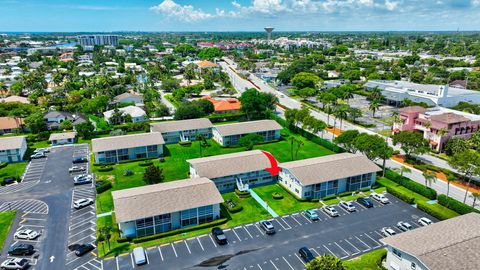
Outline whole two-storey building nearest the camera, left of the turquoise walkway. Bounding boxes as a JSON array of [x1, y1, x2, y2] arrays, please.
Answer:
[[112, 178, 224, 237]]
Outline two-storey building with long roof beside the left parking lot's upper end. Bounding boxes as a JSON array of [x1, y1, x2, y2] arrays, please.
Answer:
[[92, 132, 165, 163]]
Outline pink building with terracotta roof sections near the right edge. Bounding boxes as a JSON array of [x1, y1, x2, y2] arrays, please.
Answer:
[[393, 106, 480, 151]]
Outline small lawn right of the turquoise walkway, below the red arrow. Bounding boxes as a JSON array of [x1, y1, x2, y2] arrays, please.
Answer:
[[253, 184, 322, 215]]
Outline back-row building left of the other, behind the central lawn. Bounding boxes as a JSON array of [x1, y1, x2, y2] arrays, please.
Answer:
[[150, 118, 213, 144]]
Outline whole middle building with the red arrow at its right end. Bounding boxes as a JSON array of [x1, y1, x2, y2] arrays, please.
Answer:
[[187, 150, 277, 192]]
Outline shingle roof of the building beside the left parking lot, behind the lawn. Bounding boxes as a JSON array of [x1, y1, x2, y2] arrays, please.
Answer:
[[92, 132, 165, 153]]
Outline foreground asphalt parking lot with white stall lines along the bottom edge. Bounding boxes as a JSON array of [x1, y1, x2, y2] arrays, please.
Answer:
[[103, 195, 436, 270]]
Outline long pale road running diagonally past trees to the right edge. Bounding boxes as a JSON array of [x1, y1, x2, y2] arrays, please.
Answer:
[[221, 58, 480, 209]]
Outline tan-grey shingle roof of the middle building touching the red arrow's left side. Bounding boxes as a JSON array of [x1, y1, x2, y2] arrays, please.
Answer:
[[187, 150, 270, 179]]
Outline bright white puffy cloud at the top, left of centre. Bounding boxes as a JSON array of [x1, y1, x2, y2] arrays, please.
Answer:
[[150, 0, 214, 23]]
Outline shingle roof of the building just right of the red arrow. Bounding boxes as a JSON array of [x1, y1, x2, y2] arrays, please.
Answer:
[[279, 153, 380, 185]]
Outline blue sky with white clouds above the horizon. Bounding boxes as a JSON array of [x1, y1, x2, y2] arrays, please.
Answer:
[[0, 0, 480, 32]]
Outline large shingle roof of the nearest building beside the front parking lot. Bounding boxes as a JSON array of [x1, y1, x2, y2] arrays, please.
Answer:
[[112, 178, 224, 222]]
